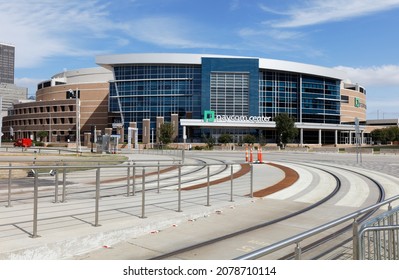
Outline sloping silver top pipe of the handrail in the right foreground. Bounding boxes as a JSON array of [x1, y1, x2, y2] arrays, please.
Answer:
[[235, 195, 399, 260]]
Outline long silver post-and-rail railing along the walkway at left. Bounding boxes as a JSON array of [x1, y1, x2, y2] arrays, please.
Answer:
[[0, 160, 253, 238]]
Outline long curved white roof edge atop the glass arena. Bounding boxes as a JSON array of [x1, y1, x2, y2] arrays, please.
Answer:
[[96, 53, 347, 80]]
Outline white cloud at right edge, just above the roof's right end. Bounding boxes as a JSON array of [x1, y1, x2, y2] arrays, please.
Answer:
[[335, 65, 399, 87]]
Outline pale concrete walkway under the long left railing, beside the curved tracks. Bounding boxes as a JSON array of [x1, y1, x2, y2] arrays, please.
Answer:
[[0, 155, 290, 259]]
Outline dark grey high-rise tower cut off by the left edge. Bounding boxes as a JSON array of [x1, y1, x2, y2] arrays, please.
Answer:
[[0, 44, 15, 84]]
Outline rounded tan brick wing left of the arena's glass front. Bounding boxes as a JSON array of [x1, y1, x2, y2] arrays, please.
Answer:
[[3, 67, 112, 142]]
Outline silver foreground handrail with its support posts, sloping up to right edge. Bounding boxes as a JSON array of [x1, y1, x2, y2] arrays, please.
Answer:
[[236, 195, 399, 260]]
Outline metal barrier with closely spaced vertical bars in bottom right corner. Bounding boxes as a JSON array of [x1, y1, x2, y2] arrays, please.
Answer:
[[355, 203, 399, 260]]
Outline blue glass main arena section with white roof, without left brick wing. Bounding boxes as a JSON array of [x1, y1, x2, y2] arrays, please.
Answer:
[[96, 53, 366, 145]]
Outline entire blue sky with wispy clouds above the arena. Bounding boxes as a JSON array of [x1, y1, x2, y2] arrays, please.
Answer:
[[0, 0, 399, 119]]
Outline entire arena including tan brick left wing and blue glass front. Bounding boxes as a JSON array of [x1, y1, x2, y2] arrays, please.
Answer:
[[3, 53, 368, 148]]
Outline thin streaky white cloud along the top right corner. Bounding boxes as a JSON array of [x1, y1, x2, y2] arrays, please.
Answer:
[[261, 0, 399, 28]]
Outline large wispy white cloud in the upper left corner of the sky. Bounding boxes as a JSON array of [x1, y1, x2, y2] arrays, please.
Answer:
[[0, 0, 115, 68]]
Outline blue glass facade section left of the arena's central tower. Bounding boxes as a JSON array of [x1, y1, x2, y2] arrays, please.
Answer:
[[109, 65, 201, 139]]
